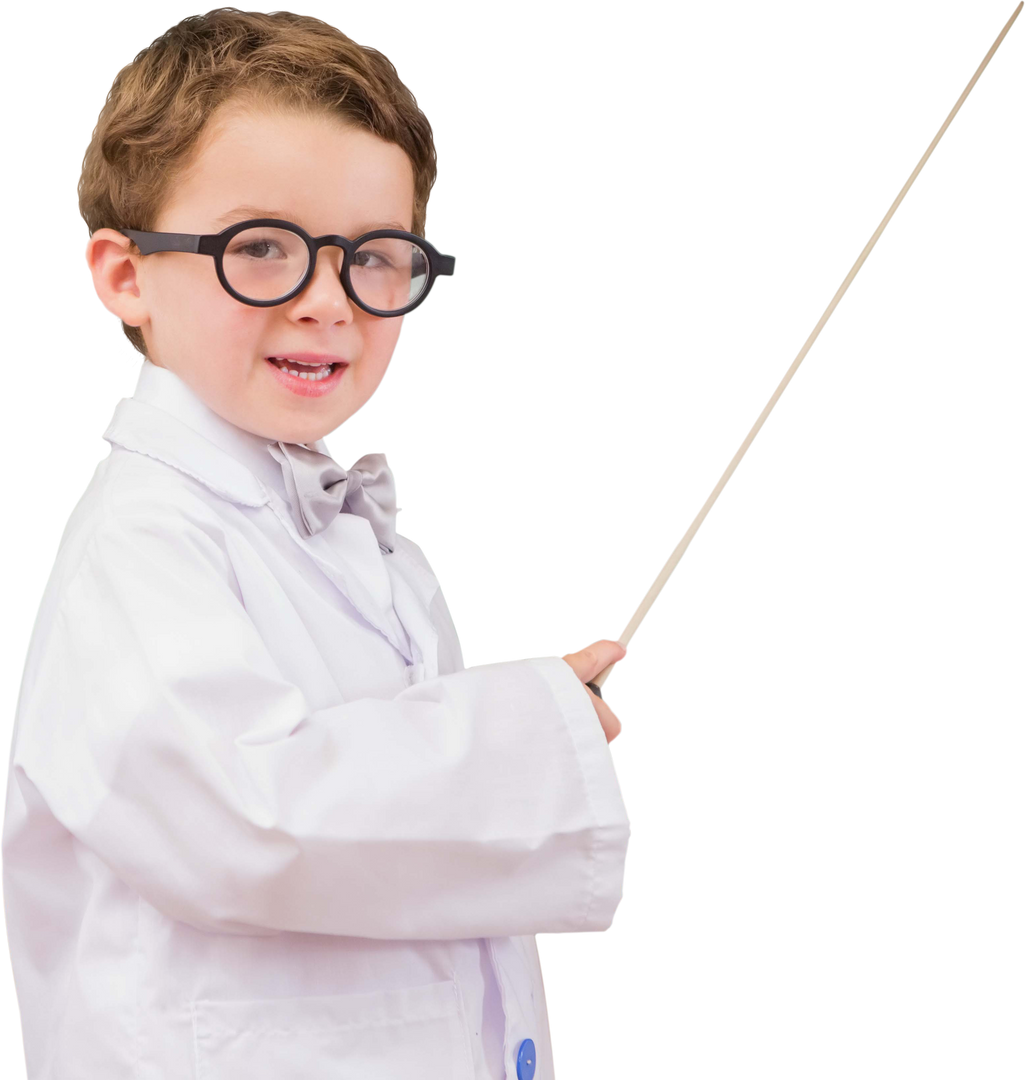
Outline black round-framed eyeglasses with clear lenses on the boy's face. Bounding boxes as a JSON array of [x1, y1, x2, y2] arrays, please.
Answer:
[[118, 217, 459, 319]]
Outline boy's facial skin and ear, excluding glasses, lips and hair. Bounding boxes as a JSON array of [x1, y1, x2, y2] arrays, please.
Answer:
[[82, 107, 414, 443]]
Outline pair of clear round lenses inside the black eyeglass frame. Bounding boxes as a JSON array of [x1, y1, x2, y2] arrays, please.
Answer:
[[224, 226, 429, 312]]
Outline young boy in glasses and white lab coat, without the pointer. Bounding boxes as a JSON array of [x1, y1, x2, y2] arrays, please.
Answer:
[[2, 9, 632, 1080]]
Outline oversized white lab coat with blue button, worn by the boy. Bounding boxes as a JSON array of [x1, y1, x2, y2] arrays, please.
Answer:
[[0, 363, 632, 1080]]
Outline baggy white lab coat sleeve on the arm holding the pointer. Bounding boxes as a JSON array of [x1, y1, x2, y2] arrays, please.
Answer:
[[13, 494, 631, 940]]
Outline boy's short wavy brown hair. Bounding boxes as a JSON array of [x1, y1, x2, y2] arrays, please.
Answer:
[[75, 4, 441, 367]]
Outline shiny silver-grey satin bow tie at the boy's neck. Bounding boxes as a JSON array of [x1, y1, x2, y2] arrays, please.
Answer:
[[267, 442, 405, 552]]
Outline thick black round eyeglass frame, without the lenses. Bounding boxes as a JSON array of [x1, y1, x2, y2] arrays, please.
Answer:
[[118, 217, 459, 319]]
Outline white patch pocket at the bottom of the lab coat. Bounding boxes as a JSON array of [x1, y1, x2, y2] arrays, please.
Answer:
[[192, 981, 473, 1080]]
